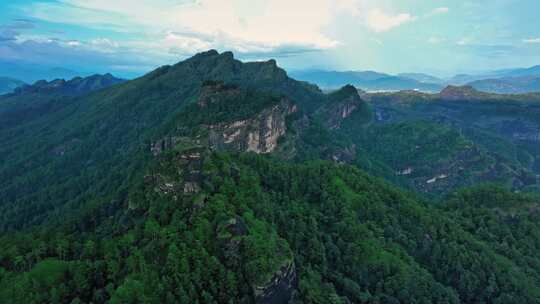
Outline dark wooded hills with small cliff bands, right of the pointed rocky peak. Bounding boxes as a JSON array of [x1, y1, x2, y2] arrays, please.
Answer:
[[358, 86, 540, 193]]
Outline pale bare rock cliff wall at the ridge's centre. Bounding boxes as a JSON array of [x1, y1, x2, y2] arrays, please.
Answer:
[[208, 98, 297, 153]]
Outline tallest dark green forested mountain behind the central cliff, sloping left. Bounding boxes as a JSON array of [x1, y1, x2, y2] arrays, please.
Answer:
[[0, 51, 325, 227]]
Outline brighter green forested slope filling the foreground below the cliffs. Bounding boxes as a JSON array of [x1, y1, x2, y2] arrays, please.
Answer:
[[0, 152, 540, 303]]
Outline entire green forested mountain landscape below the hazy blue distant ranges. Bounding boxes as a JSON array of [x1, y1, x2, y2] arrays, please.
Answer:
[[0, 51, 540, 303]]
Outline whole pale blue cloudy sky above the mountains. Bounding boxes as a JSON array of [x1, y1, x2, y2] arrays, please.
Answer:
[[0, 0, 540, 77]]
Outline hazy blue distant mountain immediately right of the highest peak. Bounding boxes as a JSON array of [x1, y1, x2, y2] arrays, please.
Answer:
[[292, 70, 442, 92]]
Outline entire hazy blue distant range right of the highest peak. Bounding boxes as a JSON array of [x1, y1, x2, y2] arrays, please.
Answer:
[[291, 66, 540, 94]]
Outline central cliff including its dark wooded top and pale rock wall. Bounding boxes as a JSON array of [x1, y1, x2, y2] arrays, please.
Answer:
[[150, 83, 297, 156]]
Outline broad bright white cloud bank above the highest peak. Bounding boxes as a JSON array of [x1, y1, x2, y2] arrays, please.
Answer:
[[24, 0, 365, 52]]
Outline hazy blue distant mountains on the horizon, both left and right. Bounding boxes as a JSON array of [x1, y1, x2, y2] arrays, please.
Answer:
[[4, 61, 540, 94]]
